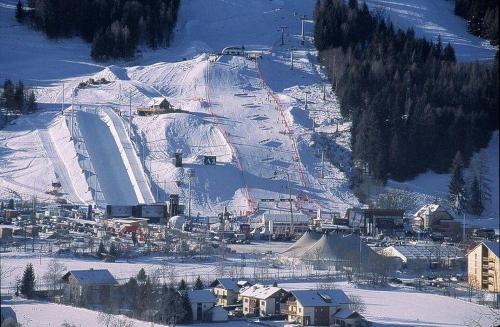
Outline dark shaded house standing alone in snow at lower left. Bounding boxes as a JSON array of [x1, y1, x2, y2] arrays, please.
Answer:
[[62, 268, 118, 305]]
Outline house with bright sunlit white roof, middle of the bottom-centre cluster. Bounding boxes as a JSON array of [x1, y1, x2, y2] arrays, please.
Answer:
[[241, 285, 288, 317]]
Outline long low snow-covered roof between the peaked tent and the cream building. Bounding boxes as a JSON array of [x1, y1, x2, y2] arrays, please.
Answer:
[[384, 244, 464, 259]]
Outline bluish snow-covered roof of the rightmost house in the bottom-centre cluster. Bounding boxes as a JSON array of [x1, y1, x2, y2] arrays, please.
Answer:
[[292, 290, 351, 307]]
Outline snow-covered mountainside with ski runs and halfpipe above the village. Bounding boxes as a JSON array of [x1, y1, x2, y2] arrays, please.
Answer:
[[0, 0, 498, 215]]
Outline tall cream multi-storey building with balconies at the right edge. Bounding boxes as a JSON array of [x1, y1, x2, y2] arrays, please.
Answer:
[[467, 241, 500, 293]]
